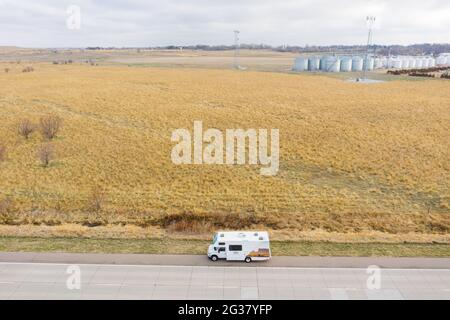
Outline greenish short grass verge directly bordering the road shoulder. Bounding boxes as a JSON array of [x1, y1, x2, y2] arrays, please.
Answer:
[[0, 237, 450, 257]]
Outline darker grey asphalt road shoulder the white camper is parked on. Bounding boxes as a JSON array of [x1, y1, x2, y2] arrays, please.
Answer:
[[0, 252, 450, 269]]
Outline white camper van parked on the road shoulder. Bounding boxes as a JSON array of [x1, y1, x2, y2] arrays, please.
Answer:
[[208, 231, 271, 263]]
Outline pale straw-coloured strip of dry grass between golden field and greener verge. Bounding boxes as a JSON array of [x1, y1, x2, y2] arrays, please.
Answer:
[[0, 224, 450, 244]]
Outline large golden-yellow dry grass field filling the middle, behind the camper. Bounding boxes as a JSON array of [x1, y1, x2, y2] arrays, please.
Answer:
[[0, 63, 450, 238]]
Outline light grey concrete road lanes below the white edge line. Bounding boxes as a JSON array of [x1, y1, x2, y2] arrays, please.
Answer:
[[0, 262, 450, 300]]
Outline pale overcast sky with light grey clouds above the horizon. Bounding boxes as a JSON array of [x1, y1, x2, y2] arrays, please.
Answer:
[[0, 0, 450, 47]]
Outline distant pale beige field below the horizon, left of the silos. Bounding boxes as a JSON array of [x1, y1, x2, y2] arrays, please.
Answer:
[[0, 47, 297, 72]]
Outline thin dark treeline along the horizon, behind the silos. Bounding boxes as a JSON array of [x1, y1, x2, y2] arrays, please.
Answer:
[[86, 43, 450, 56]]
